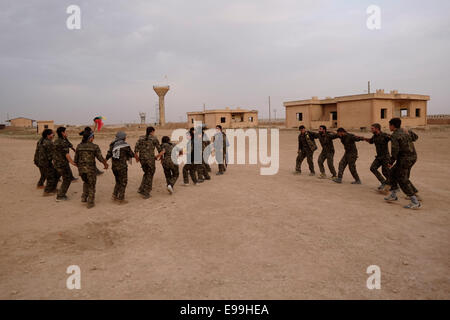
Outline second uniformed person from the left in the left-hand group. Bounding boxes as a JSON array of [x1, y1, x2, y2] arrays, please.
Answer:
[[53, 127, 75, 201]]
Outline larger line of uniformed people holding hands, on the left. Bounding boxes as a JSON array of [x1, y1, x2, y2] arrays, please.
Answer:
[[34, 125, 229, 208]]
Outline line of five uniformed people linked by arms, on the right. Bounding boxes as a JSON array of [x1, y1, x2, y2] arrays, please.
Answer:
[[295, 118, 421, 209]]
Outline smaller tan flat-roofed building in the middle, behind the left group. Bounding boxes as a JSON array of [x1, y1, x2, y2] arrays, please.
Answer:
[[187, 108, 258, 128]]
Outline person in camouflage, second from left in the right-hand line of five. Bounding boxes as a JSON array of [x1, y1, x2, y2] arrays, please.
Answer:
[[310, 125, 338, 179]]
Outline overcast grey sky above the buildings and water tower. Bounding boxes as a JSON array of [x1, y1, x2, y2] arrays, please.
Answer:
[[0, 0, 450, 124]]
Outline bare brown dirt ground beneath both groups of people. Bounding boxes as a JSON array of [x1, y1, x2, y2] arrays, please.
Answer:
[[0, 130, 450, 299]]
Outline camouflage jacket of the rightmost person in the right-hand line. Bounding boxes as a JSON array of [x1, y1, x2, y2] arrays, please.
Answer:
[[390, 129, 419, 164]]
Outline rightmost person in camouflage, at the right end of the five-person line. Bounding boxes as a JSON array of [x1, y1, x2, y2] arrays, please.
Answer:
[[385, 118, 422, 209]]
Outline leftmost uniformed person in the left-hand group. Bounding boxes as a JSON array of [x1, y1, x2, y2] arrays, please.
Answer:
[[38, 129, 59, 196]]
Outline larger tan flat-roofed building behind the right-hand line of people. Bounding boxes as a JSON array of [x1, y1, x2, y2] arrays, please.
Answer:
[[284, 90, 430, 129]]
